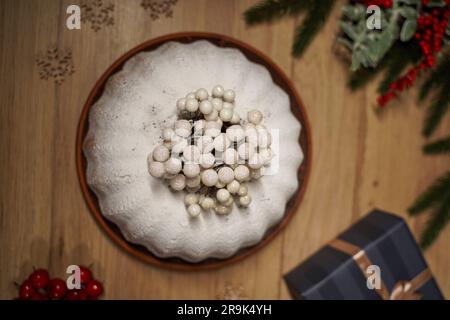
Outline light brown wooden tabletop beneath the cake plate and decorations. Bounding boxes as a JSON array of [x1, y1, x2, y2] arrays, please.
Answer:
[[0, 0, 450, 299]]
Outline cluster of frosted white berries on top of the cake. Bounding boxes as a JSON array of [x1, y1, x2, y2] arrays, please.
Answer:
[[148, 85, 273, 217]]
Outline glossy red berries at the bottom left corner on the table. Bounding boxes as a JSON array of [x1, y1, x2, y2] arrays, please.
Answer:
[[18, 266, 103, 300]]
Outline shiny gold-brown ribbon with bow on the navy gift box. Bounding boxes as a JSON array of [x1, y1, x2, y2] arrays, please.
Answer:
[[329, 239, 432, 300]]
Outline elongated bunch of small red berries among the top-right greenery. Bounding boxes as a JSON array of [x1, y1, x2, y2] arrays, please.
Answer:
[[377, 0, 450, 108]]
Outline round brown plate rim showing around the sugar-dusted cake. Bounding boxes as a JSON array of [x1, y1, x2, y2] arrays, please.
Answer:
[[76, 32, 312, 271]]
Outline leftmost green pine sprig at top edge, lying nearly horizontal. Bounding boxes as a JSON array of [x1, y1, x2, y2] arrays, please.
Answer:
[[244, 0, 312, 25]]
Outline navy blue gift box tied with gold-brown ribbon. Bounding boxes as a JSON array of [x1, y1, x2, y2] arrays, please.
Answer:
[[284, 210, 444, 300]]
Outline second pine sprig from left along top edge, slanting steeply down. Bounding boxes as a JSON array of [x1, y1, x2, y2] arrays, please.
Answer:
[[292, 0, 336, 57]]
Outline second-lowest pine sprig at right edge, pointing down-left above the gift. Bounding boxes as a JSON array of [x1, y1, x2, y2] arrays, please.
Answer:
[[408, 171, 450, 216]]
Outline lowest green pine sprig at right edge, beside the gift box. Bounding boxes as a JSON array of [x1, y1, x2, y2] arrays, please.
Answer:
[[420, 195, 450, 250]]
